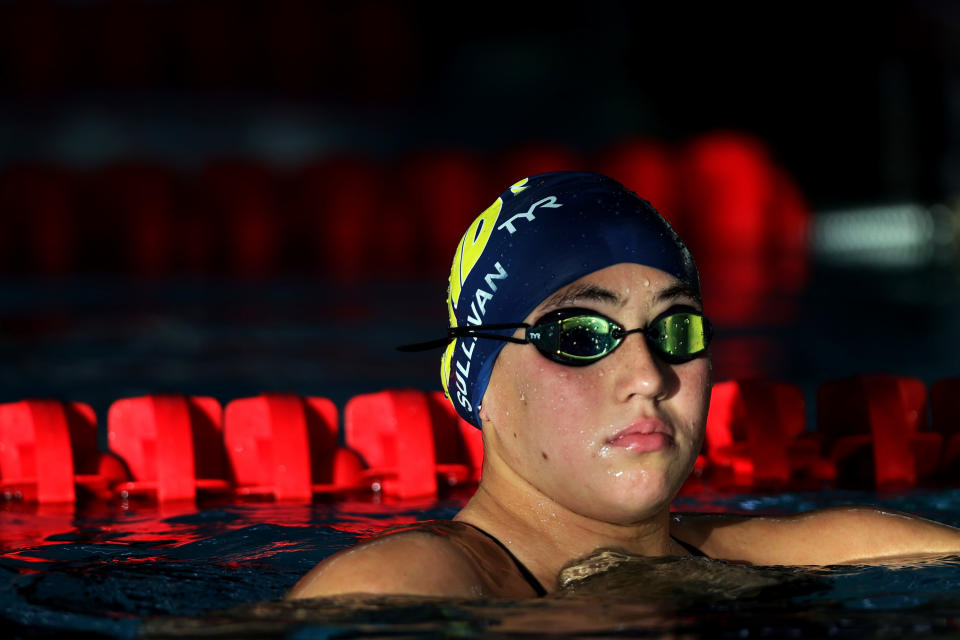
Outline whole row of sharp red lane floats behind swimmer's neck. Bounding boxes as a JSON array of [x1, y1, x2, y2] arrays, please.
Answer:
[[0, 374, 960, 508]]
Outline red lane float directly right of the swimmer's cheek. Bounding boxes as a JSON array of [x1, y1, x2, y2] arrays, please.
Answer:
[[706, 380, 835, 488]]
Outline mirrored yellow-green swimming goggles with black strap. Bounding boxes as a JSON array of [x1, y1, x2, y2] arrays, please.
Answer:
[[397, 307, 713, 367]]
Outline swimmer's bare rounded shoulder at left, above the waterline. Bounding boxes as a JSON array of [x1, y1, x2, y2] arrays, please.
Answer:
[[287, 527, 483, 598]]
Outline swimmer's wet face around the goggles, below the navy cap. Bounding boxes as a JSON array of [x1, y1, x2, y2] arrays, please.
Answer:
[[480, 263, 710, 524]]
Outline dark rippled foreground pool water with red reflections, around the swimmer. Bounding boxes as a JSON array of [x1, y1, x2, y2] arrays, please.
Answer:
[[0, 489, 960, 638]]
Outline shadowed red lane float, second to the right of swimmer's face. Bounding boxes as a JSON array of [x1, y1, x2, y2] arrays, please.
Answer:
[[817, 374, 943, 489]]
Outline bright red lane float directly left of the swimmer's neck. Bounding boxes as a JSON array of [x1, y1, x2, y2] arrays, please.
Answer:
[[344, 390, 482, 498]]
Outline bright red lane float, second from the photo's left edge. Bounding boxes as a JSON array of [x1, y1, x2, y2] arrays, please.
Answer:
[[107, 394, 231, 502]]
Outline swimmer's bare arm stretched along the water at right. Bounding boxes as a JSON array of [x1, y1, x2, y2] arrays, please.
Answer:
[[671, 506, 960, 565]]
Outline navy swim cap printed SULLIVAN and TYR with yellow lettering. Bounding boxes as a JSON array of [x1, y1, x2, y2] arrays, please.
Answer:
[[440, 171, 700, 427]]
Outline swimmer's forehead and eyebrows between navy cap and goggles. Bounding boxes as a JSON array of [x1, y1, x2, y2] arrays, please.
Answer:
[[536, 263, 700, 311]]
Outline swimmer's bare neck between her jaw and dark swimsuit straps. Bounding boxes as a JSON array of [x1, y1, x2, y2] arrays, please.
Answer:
[[455, 442, 683, 591]]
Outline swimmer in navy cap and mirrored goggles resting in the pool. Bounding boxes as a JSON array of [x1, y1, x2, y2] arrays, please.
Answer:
[[288, 172, 960, 598]]
